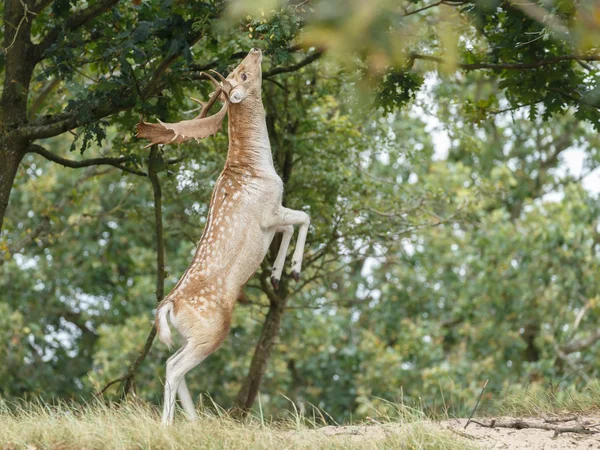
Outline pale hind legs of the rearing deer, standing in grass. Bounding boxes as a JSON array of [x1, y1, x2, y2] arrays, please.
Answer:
[[162, 343, 209, 425]]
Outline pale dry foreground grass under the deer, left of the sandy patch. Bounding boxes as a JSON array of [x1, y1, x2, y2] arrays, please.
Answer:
[[0, 402, 476, 450]]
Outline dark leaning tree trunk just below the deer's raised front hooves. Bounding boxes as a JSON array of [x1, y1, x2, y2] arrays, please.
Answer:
[[235, 279, 288, 415]]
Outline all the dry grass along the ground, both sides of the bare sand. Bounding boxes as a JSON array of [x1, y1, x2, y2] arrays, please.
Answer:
[[0, 383, 600, 450]]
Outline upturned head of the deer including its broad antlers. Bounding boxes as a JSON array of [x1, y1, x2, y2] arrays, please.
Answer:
[[136, 48, 262, 148]]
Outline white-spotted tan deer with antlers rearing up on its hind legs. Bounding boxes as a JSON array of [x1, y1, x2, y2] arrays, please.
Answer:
[[138, 48, 310, 424]]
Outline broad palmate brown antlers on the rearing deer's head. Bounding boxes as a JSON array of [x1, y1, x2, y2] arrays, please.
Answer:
[[136, 72, 231, 148]]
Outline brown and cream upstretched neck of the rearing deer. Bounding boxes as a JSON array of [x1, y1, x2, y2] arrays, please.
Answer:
[[227, 97, 275, 171]]
